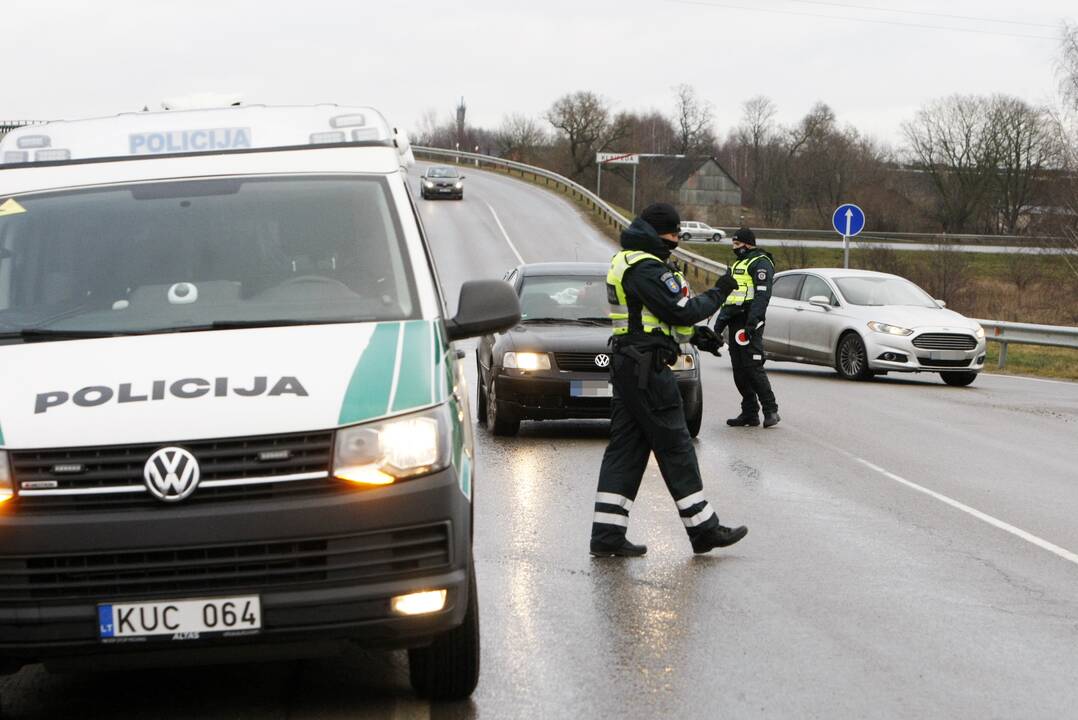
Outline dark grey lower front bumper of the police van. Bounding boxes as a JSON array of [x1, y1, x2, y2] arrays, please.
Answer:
[[0, 468, 471, 669]]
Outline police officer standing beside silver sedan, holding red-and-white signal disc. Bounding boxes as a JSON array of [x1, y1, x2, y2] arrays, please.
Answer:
[[715, 227, 780, 428]]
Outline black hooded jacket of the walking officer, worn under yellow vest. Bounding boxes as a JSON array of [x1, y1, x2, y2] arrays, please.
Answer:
[[621, 218, 725, 351]]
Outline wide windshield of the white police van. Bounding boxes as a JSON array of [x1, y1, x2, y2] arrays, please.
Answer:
[[0, 177, 417, 334]]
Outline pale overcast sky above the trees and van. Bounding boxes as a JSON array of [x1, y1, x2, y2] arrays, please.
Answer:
[[0, 0, 1078, 142]]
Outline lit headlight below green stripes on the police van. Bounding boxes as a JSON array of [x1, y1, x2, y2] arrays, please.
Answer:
[[333, 404, 452, 485]]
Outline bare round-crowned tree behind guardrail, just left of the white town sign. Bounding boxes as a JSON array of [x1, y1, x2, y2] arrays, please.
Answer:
[[547, 91, 627, 178]]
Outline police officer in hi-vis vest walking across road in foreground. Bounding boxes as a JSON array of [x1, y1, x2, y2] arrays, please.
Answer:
[[591, 203, 748, 557]]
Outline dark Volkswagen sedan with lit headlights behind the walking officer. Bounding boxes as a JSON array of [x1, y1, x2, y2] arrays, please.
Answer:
[[476, 263, 704, 437]]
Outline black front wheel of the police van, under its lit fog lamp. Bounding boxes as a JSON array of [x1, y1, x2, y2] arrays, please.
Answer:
[[407, 567, 479, 701]]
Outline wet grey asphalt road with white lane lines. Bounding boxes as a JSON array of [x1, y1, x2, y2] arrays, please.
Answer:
[[0, 164, 1078, 718]]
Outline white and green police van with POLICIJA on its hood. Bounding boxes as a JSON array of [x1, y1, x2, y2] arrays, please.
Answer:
[[0, 106, 520, 698]]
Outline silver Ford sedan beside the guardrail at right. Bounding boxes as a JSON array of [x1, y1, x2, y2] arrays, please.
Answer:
[[763, 268, 985, 386]]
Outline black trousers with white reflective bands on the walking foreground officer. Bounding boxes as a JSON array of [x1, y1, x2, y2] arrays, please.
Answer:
[[592, 350, 719, 543]]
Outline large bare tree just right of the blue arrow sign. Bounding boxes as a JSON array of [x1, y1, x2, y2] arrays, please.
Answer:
[[902, 95, 996, 233]]
